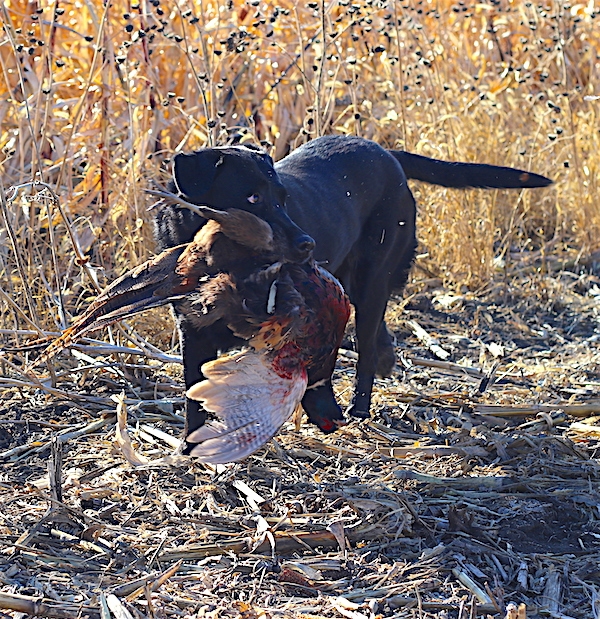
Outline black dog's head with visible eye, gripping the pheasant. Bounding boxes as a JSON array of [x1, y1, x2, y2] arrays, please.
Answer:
[[173, 146, 315, 262]]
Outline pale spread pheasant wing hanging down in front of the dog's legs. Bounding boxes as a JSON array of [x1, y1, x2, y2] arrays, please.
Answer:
[[187, 350, 307, 464]]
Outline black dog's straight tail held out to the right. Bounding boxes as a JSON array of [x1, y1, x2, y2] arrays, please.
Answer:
[[390, 150, 552, 189]]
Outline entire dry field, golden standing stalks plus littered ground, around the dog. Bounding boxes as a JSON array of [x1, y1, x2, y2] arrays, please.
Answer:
[[0, 0, 600, 619]]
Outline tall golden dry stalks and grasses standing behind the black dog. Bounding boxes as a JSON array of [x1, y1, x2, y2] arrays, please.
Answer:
[[0, 0, 600, 340]]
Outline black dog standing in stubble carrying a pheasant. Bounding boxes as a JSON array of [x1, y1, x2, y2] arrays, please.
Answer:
[[155, 136, 551, 448]]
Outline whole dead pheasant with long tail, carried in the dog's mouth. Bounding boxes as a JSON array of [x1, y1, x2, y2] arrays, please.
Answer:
[[41, 201, 350, 464]]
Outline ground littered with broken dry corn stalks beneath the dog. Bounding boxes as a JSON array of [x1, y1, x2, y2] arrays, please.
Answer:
[[0, 255, 600, 619]]
